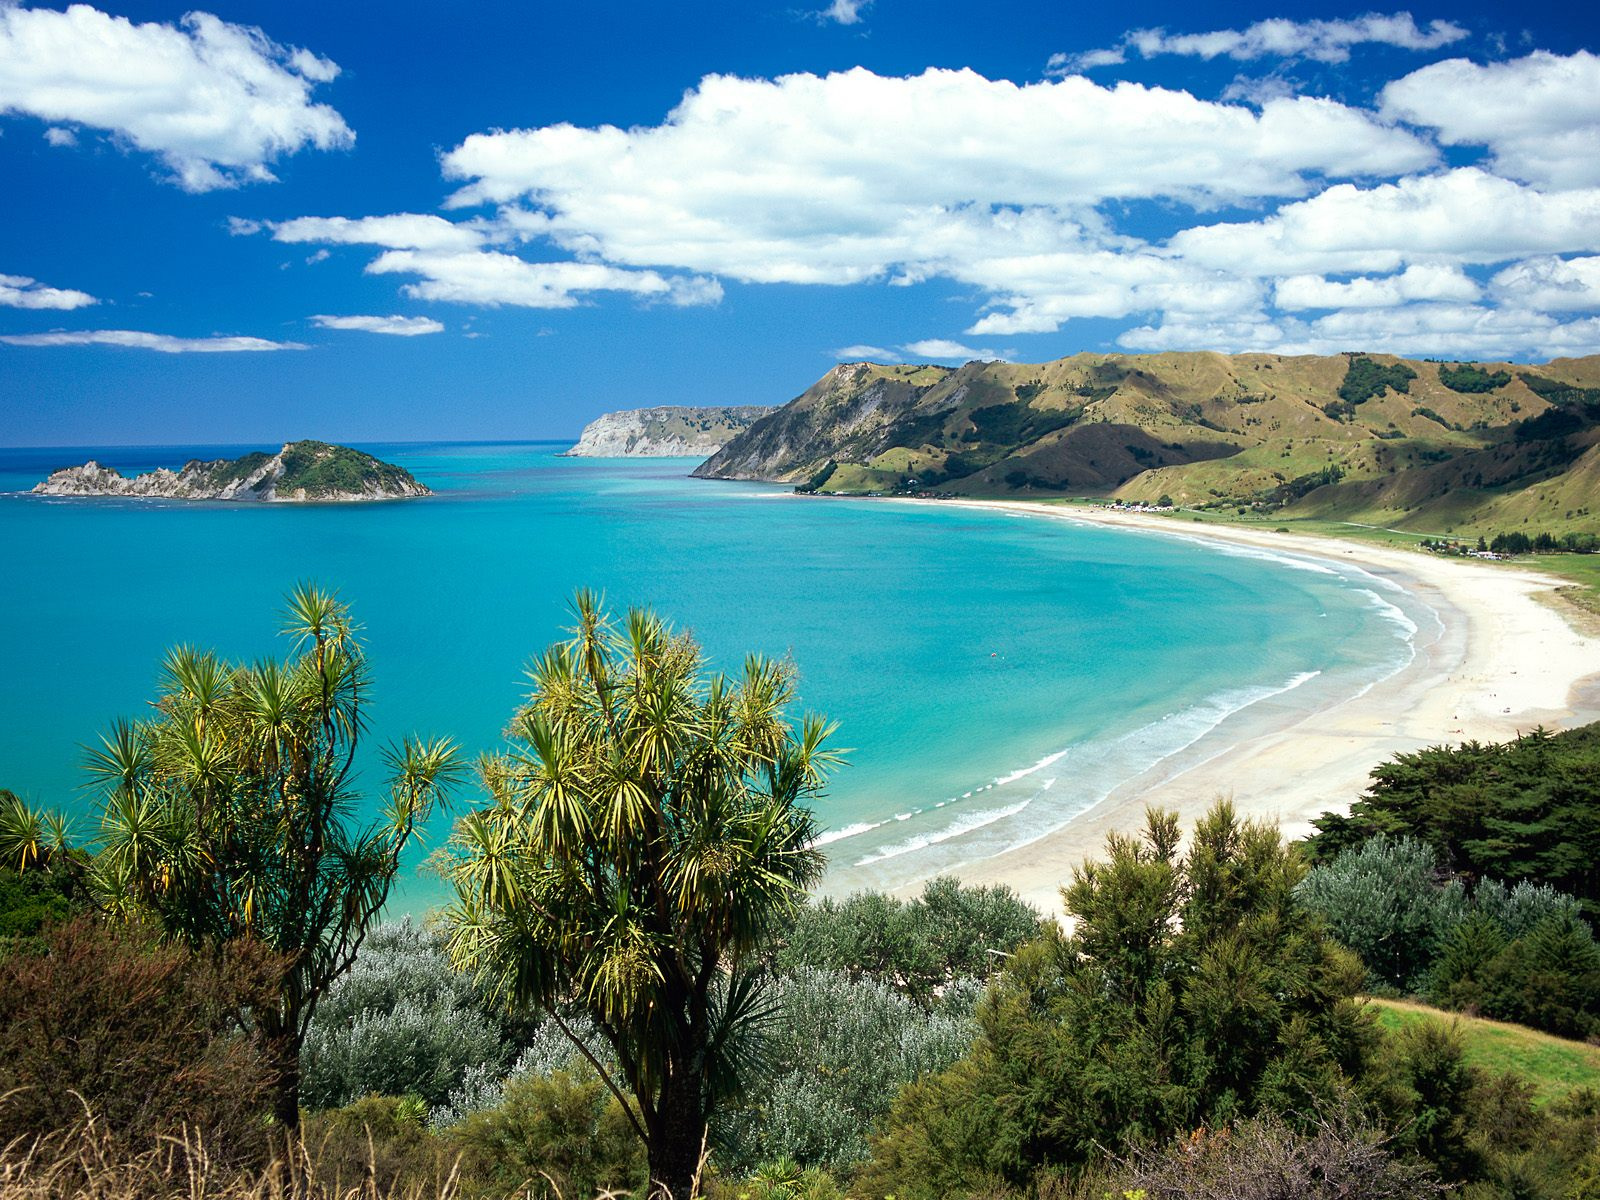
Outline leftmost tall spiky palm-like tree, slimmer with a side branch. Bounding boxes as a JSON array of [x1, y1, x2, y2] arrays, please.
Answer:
[[86, 584, 461, 1128]]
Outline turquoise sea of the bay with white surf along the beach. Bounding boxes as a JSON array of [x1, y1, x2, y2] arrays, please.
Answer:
[[0, 443, 1432, 910]]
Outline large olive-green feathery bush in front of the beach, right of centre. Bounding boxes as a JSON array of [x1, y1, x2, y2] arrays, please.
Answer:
[[864, 803, 1373, 1200]]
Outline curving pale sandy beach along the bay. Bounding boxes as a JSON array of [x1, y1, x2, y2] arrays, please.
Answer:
[[930, 501, 1600, 912]]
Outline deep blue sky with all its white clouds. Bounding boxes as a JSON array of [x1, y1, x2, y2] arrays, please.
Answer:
[[0, 0, 1600, 446]]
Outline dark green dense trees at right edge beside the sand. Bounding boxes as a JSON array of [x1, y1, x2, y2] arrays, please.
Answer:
[[1307, 725, 1600, 917]]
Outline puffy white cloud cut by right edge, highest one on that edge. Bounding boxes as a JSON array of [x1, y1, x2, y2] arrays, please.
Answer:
[[1381, 50, 1600, 187]]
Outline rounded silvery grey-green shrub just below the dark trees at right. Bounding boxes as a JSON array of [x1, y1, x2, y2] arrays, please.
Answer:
[[1294, 837, 1467, 992]]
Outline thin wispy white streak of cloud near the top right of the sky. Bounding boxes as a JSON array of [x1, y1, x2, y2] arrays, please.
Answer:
[[1050, 13, 1467, 74]]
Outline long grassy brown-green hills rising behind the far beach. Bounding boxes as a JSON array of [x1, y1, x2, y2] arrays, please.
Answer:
[[694, 352, 1600, 533]]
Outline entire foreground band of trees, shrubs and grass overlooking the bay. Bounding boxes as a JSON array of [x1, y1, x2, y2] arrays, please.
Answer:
[[0, 586, 1600, 1200]]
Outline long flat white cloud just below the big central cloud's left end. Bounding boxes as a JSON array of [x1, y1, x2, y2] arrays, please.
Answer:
[[366, 250, 722, 309]]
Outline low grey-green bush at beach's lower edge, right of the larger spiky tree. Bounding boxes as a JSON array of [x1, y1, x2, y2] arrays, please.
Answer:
[[774, 877, 1040, 1003]]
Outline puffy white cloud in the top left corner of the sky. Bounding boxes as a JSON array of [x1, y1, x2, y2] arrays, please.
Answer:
[[0, 5, 355, 192]]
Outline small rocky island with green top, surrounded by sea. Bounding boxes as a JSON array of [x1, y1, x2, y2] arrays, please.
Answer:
[[34, 442, 432, 502]]
